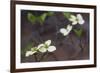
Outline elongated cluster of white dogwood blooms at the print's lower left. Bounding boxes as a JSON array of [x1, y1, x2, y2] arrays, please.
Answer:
[[25, 40, 56, 57]]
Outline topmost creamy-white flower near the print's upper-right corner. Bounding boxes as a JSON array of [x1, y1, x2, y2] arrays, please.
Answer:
[[69, 14, 85, 25]]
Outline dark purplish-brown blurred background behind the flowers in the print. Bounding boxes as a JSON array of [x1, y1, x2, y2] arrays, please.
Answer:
[[21, 10, 89, 62]]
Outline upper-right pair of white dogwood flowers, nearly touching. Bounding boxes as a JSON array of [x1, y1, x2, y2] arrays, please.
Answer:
[[60, 14, 85, 36]]
